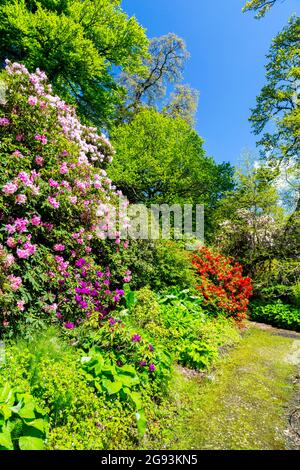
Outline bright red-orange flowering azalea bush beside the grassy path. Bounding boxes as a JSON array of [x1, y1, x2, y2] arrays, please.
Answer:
[[193, 247, 252, 320]]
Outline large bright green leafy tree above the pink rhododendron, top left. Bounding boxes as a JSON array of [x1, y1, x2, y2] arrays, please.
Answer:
[[0, 0, 148, 126]]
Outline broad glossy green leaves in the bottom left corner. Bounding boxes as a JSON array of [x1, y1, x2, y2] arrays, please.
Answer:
[[0, 382, 48, 450]]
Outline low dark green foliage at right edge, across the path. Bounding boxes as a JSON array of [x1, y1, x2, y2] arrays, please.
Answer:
[[251, 301, 300, 331]]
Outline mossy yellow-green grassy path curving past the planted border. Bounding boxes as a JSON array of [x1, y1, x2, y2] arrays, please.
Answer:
[[162, 327, 300, 450]]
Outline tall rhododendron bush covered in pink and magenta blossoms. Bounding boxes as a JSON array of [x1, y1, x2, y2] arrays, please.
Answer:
[[0, 61, 130, 331]]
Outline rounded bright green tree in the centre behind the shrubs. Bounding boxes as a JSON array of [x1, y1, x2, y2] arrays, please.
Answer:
[[108, 108, 233, 237]]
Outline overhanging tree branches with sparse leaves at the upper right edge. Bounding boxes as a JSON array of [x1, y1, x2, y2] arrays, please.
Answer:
[[250, 17, 300, 160]]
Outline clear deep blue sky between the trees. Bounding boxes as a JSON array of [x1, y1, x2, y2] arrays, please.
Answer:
[[122, 0, 299, 164]]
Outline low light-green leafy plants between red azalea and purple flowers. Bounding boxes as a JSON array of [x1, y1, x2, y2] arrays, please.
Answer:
[[121, 288, 239, 369]]
